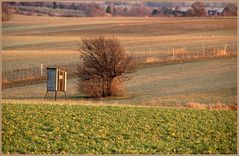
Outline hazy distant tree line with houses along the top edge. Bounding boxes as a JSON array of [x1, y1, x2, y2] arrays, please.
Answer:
[[3, 1, 237, 17]]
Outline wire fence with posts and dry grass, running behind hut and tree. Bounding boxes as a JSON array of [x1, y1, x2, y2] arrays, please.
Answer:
[[2, 44, 237, 88]]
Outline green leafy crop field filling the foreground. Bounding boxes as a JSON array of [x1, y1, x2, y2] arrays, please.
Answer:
[[2, 102, 237, 154]]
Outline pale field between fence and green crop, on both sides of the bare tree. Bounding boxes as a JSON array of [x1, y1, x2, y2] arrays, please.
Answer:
[[2, 58, 237, 106]]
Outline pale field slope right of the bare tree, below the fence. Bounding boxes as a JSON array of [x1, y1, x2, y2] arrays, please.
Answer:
[[125, 58, 237, 105]]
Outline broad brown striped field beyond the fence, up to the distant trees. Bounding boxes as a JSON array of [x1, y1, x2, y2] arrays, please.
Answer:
[[2, 15, 236, 70]]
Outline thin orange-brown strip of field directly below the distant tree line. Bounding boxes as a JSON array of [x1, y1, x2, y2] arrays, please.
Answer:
[[8, 15, 236, 25]]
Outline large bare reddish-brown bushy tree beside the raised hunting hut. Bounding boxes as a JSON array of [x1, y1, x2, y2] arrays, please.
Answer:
[[79, 37, 136, 97]]
